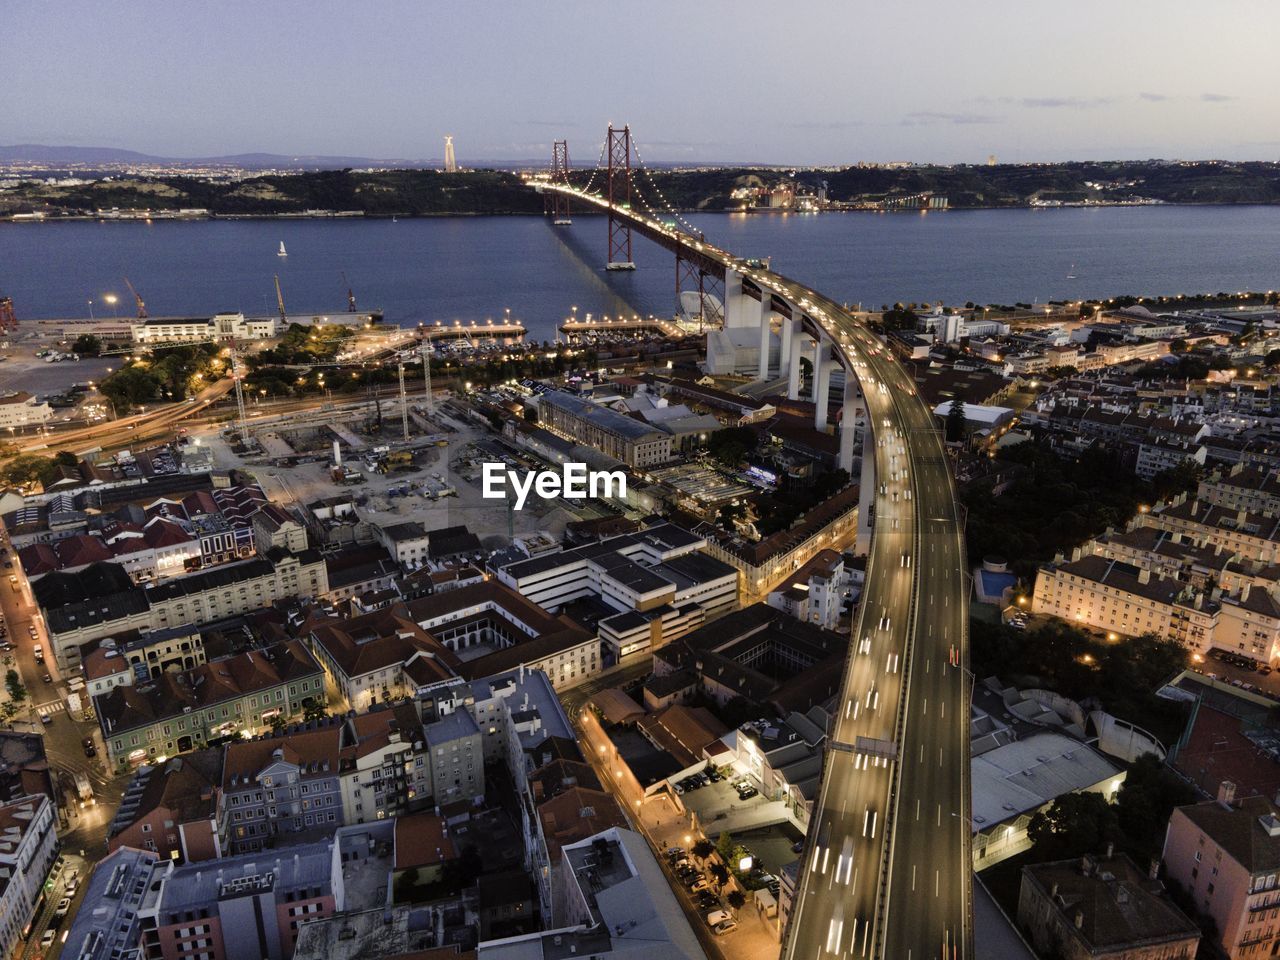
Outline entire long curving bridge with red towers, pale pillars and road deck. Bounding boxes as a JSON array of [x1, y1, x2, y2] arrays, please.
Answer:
[[529, 125, 974, 960]]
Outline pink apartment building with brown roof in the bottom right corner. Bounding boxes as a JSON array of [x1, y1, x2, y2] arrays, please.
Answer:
[[1164, 798, 1280, 960]]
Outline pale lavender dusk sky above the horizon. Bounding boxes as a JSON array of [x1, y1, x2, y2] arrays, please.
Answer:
[[0, 0, 1280, 165]]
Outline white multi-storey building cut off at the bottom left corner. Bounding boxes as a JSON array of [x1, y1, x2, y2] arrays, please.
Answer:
[[0, 794, 60, 956]]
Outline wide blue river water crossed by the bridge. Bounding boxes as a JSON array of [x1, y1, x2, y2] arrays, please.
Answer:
[[0, 206, 1280, 339]]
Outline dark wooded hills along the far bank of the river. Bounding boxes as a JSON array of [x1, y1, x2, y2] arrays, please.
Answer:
[[0, 158, 1280, 216]]
